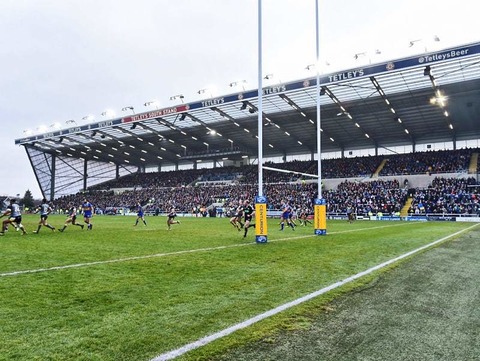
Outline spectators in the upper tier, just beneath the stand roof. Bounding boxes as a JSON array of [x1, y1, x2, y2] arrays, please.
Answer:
[[90, 149, 479, 190]]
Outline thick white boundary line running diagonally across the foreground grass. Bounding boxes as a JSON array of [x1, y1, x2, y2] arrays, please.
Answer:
[[151, 224, 478, 361]]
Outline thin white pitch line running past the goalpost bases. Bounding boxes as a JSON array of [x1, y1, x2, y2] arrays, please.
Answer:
[[0, 224, 412, 277]]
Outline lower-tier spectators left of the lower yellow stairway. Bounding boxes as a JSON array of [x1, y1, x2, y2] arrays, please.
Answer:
[[54, 180, 407, 215]]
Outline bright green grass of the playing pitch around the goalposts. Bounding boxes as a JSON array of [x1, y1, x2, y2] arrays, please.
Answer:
[[0, 215, 471, 360]]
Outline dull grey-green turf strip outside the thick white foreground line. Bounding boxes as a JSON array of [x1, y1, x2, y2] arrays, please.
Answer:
[[214, 227, 480, 361]]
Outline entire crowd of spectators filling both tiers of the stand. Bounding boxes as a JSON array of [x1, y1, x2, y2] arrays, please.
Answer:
[[54, 150, 479, 215]]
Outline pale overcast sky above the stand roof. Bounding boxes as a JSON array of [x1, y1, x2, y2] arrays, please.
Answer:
[[0, 0, 480, 198]]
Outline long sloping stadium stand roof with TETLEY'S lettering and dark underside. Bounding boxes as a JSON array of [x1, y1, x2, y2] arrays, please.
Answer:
[[15, 43, 480, 196]]
